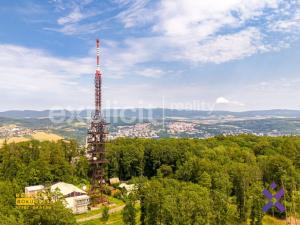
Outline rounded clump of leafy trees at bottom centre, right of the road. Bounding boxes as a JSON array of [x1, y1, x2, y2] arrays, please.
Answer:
[[141, 179, 213, 225]]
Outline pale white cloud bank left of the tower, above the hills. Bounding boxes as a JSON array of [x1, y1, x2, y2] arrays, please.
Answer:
[[0, 45, 94, 110]]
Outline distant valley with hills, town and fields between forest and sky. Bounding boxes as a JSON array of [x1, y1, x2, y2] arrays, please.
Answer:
[[0, 109, 300, 144]]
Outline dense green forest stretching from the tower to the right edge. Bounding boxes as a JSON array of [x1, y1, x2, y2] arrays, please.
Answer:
[[107, 135, 300, 225]]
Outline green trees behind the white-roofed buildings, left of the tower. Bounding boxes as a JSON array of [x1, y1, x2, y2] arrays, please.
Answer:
[[0, 141, 88, 186]]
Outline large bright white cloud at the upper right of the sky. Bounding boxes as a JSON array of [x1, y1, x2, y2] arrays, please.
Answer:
[[113, 0, 297, 63]]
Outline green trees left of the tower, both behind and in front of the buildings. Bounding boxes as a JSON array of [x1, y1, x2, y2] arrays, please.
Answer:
[[0, 141, 88, 225]]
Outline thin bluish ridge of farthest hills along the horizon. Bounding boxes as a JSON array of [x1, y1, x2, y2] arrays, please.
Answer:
[[0, 108, 300, 119]]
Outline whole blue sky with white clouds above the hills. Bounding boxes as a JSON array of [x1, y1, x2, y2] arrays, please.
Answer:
[[0, 0, 300, 111]]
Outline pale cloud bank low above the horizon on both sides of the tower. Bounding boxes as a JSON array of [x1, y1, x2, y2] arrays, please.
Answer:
[[0, 43, 300, 111]]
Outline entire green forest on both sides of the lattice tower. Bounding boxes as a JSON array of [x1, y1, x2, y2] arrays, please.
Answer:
[[0, 135, 300, 225]]
